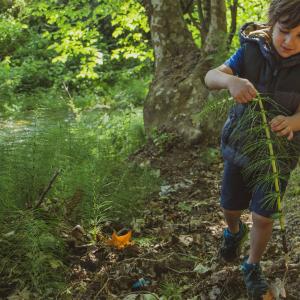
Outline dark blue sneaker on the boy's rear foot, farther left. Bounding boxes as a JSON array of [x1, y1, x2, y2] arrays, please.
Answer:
[[219, 221, 249, 262]]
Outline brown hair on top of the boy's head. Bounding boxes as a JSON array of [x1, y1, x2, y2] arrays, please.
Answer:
[[268, 0, 300, 29]]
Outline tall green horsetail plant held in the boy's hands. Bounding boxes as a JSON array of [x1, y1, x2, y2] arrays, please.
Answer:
[[198, 95, 299, 253]]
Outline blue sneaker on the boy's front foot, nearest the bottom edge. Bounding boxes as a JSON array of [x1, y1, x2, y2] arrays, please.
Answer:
[[241, 256, 269, 300]]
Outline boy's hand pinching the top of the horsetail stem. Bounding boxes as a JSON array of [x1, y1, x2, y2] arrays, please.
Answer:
[[228, 76, 257, 103]]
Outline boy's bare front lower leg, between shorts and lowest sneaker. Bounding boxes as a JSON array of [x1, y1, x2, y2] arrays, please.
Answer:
[[247, 212, 273, 264]]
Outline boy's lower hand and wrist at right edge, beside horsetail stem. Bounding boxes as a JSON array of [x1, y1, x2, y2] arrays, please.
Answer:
[[270, 105, 300, 140]]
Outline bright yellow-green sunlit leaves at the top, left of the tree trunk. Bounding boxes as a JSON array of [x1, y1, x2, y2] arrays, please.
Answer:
[[22, 0, 153, 79]]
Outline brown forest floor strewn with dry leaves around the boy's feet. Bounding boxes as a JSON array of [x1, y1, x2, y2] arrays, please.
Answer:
[[67, 142, 300, 300]]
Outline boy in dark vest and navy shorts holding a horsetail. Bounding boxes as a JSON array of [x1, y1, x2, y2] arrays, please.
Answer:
[[205, 0, 300, 299]]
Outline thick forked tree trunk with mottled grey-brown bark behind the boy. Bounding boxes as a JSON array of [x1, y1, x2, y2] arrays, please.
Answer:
[[144, 0, 226, 143]]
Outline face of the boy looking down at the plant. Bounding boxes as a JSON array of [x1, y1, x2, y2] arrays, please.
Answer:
[[272, 22, 300, 58]]
